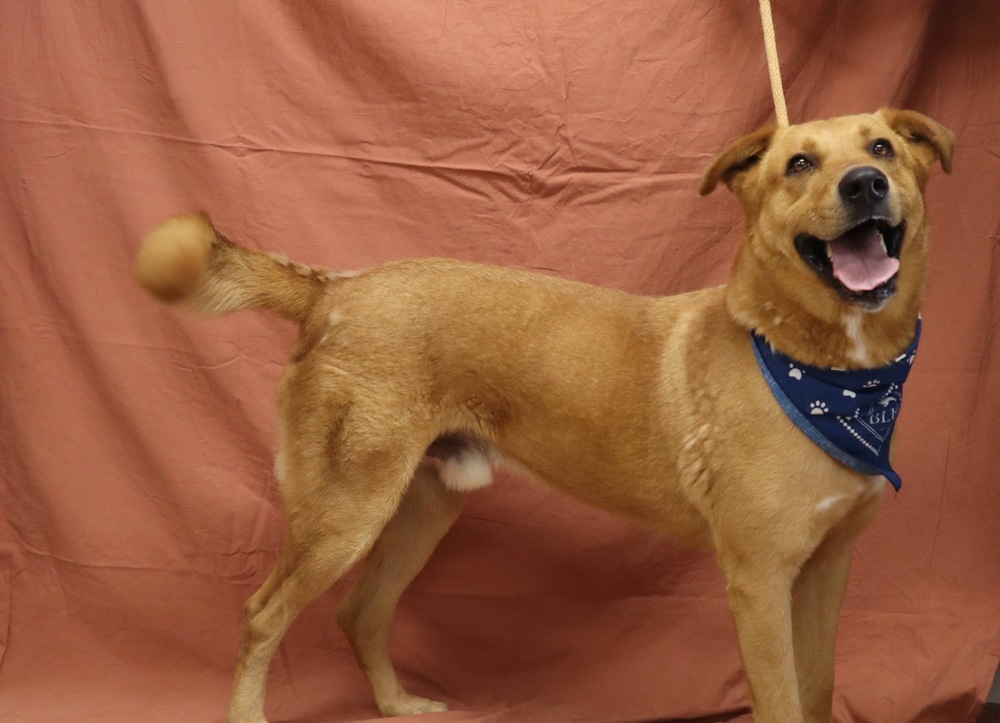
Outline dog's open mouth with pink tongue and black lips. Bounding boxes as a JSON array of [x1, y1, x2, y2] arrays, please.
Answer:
[[795, 217, 906, 307]]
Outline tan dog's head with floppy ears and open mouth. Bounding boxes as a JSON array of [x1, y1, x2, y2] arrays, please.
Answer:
[[699, 109, 954, 316]]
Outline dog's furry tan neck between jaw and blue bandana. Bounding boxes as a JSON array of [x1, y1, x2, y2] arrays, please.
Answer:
[[726, 244, 923, 369]]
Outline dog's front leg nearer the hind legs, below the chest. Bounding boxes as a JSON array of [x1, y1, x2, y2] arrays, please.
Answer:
[[719, 555, 803, 723]]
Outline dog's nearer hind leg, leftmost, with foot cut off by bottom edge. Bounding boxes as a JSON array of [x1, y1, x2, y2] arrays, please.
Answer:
[[229, 450, 412, 723]]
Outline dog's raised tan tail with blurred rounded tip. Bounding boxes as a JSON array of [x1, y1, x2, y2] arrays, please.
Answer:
[[135, 213, 339, 323]]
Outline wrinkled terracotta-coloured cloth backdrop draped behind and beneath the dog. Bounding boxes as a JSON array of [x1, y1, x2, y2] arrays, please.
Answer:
[[0, 0, 1000, 723]]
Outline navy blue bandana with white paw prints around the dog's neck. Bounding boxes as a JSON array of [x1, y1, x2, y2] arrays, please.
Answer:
[[750, 320, 920, 490]]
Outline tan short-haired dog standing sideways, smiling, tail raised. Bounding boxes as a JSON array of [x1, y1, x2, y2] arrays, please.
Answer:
[[136, 110, 953, 723]]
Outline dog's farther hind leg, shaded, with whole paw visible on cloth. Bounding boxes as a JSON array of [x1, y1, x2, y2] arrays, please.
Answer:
[[337, 464, 466, 716]]
